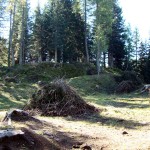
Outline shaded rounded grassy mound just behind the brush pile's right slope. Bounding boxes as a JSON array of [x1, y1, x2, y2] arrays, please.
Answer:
[[69, 74, 117, 95]]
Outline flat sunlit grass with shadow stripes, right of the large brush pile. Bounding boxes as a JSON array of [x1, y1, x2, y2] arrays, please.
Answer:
[[84, 93, 150, 128]]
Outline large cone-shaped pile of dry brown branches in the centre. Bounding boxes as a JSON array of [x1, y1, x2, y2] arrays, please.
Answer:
[[26, 79, 97, 116]]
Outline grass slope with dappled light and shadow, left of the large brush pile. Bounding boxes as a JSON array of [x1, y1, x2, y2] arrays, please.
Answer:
[[0, 83, 37, 110]]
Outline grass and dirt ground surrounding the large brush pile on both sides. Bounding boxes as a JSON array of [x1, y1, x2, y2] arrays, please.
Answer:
[[0, 75, 150, 150]]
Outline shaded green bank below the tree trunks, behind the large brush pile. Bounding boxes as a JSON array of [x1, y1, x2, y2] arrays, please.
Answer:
[[0, 63, 90, 83]]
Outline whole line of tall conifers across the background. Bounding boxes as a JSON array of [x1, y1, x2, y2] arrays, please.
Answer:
[[0, 0, 150, 82]]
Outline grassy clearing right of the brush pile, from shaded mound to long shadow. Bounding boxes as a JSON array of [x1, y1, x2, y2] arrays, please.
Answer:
[[70, 76, 150, 129]]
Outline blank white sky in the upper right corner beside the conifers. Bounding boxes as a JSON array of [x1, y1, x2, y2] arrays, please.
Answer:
[[119, 0, 150, 39]]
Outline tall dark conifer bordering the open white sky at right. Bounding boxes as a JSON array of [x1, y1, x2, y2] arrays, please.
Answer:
[[108, 2, 126, 69]]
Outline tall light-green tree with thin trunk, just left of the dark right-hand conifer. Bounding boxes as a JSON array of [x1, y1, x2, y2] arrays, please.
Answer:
[[94, 0, 114, 74]]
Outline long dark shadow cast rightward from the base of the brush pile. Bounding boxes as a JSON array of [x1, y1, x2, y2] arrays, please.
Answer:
[[65, 114, 150, 129]]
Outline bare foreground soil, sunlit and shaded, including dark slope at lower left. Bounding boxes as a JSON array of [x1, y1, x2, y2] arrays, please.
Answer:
[[0, 112, 150, 150]]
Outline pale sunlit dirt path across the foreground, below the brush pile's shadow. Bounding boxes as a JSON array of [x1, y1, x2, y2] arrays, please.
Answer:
[[1, 110, 150, 150]]
